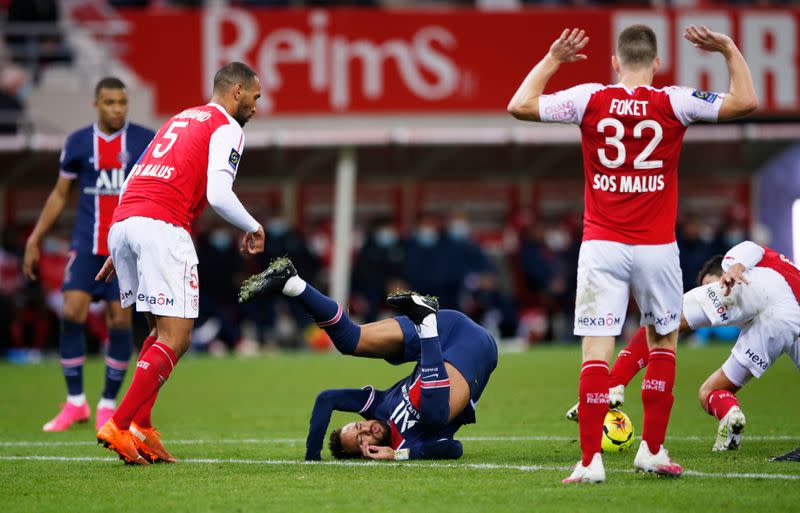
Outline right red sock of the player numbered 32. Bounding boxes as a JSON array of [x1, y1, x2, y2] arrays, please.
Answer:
[[642, 349, 675, 454]]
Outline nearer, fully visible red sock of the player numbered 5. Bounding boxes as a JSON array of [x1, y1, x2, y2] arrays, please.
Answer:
[[112, 342, 177, 429]]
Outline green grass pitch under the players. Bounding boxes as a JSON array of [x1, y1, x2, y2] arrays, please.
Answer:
[[0, 346, 800, 513]]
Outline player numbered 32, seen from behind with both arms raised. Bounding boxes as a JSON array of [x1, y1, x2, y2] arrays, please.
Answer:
[[508, 25, 758, 483]]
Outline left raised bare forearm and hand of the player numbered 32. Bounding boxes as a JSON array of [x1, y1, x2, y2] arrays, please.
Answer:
[[508, 29, 589, 121]]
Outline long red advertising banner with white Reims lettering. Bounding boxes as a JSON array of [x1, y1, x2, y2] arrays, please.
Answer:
[[119, 8, 800, 116]]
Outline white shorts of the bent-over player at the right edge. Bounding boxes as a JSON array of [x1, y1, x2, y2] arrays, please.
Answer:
[[723, 308, 800, 381]]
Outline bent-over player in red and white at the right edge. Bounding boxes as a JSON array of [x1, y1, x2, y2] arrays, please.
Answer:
[[567, 241, 800, 451]]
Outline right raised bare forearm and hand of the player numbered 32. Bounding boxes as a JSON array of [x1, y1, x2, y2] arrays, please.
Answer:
[[683, 25, 758, 121]]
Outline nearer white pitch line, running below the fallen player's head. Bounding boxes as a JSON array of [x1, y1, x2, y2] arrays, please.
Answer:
[[0, 456, 800, 481]]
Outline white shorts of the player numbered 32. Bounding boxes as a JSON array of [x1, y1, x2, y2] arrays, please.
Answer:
[[574, 240, 683, 337]]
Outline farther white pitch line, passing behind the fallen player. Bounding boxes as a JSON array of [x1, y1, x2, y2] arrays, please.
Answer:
[[0, 435, 800, 447]]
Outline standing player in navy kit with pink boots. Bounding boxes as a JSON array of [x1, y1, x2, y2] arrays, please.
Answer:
[[23, 77, 154, 431]]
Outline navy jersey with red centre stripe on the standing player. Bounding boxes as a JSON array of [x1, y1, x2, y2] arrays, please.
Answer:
[[60, 123, 155, 256]]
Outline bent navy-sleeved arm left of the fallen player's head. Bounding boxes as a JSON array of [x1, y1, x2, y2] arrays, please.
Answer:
[[306, 387, 375, 461]]
